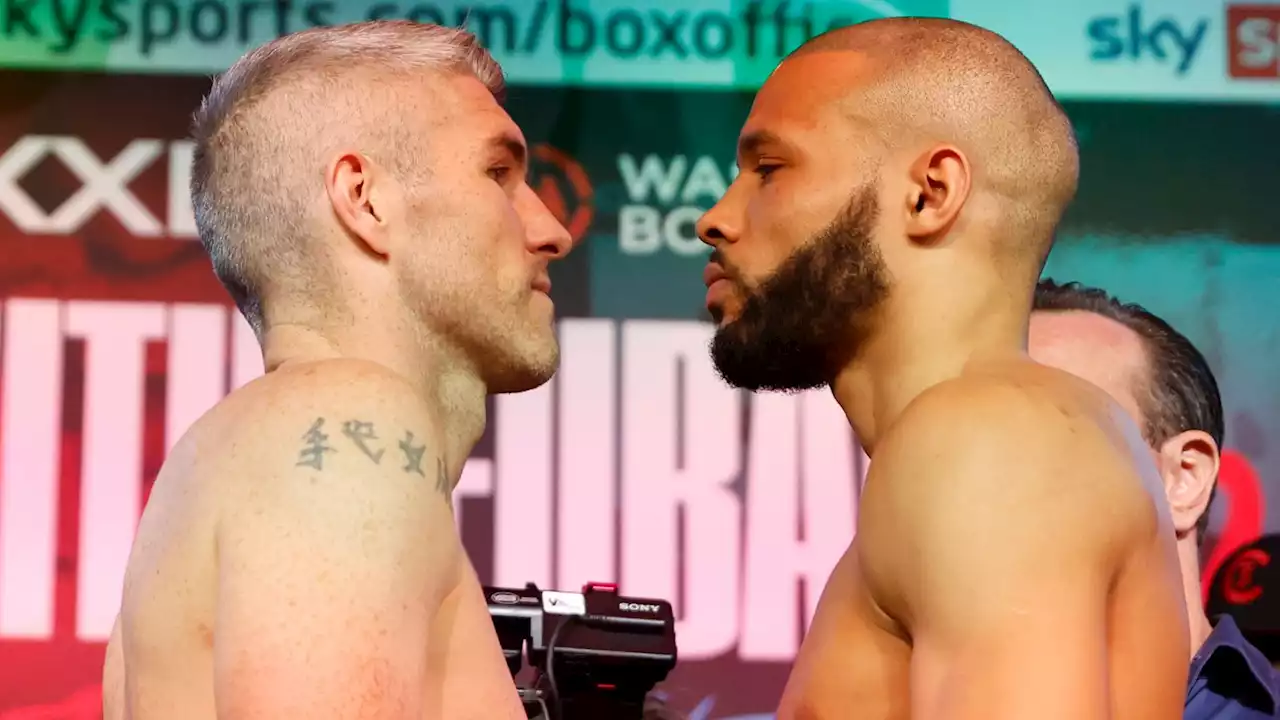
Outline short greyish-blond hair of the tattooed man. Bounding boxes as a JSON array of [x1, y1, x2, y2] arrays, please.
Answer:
[[191, 20, 506, 337]]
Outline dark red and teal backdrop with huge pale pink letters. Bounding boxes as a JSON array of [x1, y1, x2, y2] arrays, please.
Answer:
[[0, 0, 1280, 720]]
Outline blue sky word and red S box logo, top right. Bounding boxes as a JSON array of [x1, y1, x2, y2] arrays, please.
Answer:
[[1085, 3, 1280, 79]]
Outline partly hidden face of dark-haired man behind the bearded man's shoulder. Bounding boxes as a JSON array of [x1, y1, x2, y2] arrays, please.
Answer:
[[1028, 310, 1147, 428]]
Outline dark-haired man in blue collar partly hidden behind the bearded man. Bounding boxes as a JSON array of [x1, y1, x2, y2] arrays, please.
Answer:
[[1028, 281, 1280, 720]]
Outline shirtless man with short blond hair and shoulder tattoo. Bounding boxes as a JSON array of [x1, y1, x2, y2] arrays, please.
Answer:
[[104, 22, 571, 720]]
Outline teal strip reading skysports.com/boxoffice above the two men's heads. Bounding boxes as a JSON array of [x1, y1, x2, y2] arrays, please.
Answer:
[[0, 0, 947, 87]]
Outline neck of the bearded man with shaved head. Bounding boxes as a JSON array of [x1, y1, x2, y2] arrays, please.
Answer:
[[831, 271, 1030, 456]]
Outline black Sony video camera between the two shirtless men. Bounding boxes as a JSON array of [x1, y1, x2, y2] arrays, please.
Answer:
[[484, 583, 676, 720]]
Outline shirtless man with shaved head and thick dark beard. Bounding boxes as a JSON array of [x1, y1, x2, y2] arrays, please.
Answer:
[[699, 18, 1189, 720]]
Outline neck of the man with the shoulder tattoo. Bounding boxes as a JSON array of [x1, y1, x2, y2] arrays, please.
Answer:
[[260, 304, 488, 474]]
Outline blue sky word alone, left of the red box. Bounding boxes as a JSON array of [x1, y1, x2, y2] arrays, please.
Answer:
[[1085, 4, 1208, 76]]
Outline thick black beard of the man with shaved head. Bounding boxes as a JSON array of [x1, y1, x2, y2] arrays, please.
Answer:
[[712, 186, 890, 392]]
